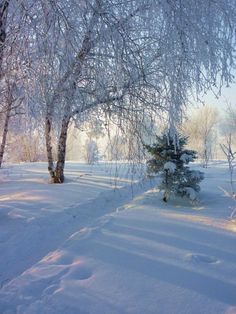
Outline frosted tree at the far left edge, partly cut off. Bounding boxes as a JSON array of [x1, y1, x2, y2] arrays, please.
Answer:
[[0, 0, 25, 168]]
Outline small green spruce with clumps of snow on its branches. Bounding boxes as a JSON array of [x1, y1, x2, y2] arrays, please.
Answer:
[[145, 132, 204, 202]]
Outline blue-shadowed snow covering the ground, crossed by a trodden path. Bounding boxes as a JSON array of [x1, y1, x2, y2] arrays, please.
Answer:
[[0, 162, 236, 314]]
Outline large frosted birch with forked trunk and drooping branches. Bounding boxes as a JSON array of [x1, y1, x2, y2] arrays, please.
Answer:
[[11, 0, 236, 183]]
